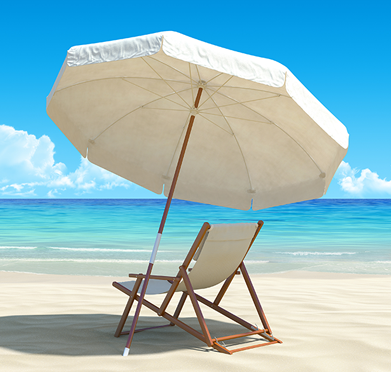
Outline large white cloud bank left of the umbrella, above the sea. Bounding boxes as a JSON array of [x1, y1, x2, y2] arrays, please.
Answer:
[[0, 125, 131, 198]]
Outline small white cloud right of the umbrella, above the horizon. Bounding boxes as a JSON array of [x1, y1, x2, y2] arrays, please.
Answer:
[[336, 161, 391, 197]]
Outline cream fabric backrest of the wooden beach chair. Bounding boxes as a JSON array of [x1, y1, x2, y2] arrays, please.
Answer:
[[177, 223, 258, 292]]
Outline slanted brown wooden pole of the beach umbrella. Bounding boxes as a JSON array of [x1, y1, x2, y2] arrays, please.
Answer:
[[123, 88, 203, 356]]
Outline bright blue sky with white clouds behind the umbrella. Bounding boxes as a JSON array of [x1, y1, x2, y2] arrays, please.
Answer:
[[0, 1, 391, 198]]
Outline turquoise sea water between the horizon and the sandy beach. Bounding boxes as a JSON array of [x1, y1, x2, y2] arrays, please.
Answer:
[[0, 199, 391, 276]]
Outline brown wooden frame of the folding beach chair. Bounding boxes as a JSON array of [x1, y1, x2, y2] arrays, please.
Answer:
[[113, 221, 282, 354]]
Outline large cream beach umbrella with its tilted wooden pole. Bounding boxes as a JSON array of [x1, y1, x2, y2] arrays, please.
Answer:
[[47, 32, 348, 354]]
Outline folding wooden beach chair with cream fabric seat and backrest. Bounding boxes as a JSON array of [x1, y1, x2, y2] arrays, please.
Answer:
[[113, 221, 281, 355]]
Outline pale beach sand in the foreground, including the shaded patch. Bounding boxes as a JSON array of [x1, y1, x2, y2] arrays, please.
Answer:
[[0, 272, 391, 372]]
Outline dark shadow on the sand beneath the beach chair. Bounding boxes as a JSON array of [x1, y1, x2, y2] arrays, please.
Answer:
[[0, 314, 261, 356]]
